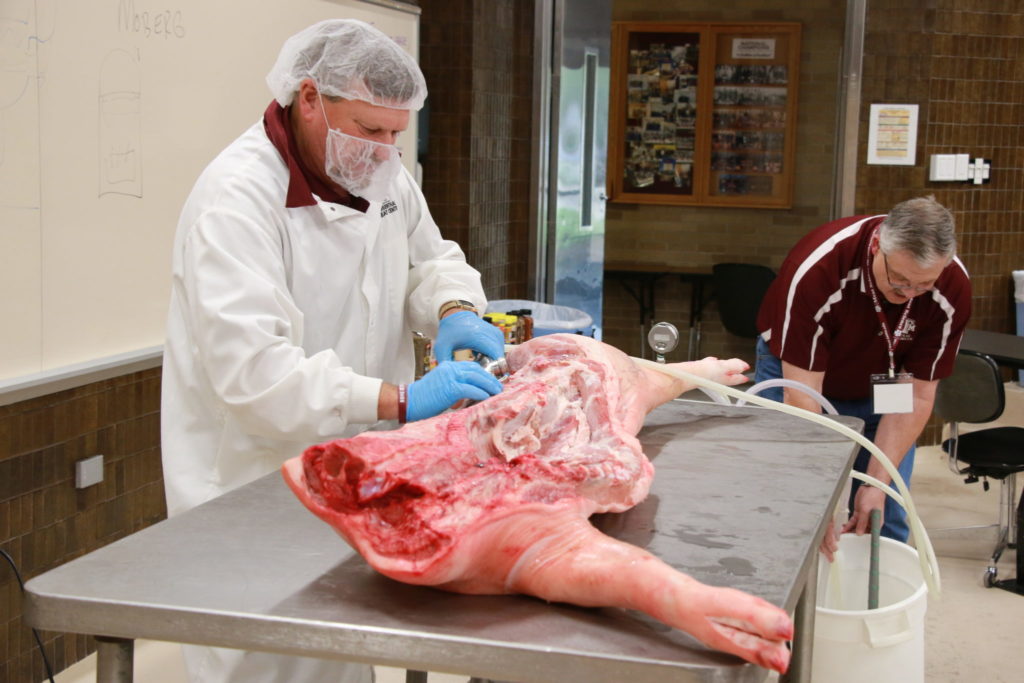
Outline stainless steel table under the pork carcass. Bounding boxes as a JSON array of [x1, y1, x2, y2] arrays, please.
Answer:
[[25, 401, 859, 683]]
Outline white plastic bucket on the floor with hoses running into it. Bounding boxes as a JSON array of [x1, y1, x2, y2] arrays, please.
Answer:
[[811, 533, 928, 683]]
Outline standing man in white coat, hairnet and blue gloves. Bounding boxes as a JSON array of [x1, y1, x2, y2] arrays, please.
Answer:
[[161, 19, 504, 683]]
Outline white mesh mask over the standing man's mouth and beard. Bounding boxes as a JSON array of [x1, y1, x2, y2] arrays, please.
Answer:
[[321, 99, 401, 202]]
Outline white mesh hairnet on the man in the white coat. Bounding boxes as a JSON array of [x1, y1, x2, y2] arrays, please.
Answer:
[[266, 19, 427, 110]]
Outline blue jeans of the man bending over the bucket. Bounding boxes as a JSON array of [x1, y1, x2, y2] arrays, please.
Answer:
[[754, 337, 916, 543]]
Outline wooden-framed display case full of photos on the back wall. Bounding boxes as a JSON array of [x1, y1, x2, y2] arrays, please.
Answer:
[[608, 22, 800, 208]]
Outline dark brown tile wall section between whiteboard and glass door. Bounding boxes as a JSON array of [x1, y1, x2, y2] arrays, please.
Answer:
[[420, 0, 534, 299]]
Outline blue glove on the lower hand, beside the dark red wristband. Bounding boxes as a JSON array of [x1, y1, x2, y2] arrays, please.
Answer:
[[406, 358, 503, 422]]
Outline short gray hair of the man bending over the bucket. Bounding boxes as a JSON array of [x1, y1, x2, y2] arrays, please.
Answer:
[[879, 195, 956, 267]]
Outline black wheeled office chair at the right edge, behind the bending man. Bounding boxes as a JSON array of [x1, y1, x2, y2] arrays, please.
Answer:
[[935, 350, 1024, 593]]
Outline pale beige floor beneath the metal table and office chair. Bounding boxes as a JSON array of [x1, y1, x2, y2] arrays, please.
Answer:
[[56, 383, 1024, 683]]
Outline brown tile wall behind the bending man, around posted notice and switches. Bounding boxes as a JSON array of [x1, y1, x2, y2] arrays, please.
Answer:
[[856, 0, 1024, 443]]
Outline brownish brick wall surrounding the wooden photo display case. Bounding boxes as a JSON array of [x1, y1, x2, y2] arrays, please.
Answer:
[[604, 0, 844, 365]]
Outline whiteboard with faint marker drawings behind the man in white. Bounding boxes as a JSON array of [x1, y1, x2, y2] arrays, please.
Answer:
[[0, 0, 419, 379]]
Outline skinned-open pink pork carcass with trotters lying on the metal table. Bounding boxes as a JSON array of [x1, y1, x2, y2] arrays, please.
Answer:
[[283, 335, 793, 672]]
